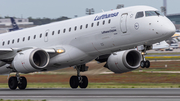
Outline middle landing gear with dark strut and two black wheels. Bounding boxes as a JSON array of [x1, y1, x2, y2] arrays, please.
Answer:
[[69, 64, 88, 88]]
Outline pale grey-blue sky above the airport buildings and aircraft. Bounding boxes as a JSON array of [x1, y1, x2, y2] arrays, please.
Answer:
[[0, 0, 180, 18]]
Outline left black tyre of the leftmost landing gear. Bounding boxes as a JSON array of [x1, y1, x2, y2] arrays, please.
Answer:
[[8, 76, 18, 90]]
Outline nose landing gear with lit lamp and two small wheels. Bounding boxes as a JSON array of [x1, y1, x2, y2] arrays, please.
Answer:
[[140, 46, 150, 68]]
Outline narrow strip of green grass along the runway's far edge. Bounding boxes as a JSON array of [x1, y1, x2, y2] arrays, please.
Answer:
[[0, 82, 180, 88]]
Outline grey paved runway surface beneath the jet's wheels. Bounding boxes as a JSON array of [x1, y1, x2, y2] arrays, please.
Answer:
[[0, 88, 180, 101]]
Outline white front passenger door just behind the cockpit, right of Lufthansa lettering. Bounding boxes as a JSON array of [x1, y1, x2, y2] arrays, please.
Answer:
[[120, 13, 128, 33]]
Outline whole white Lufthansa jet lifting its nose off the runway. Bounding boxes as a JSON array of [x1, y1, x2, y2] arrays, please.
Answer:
[[0, 6, 175, 90]]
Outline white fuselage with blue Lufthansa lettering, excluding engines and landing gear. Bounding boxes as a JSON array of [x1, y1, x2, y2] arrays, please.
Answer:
[[0, 6, 175, 70]]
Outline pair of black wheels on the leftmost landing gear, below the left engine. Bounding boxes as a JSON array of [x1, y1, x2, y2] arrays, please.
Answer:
[[8, 73, 27, 90]]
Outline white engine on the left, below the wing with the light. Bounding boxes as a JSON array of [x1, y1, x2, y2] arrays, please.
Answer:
[[12, 48, 49, 73]]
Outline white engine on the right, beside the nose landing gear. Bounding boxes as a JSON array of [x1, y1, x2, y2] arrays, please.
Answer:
[[107, 50, 142, 73]]
